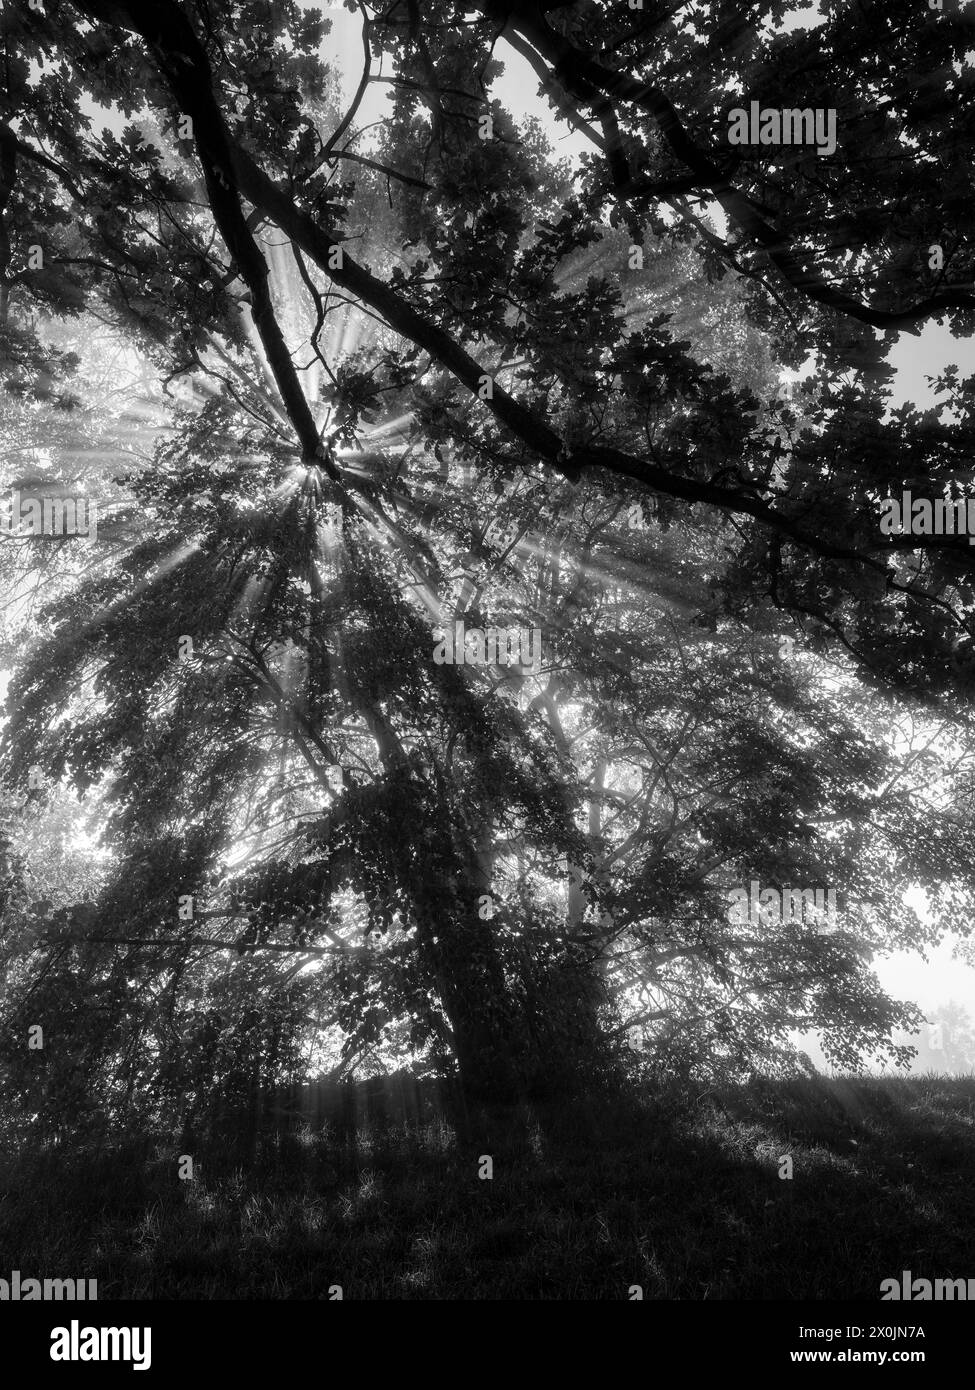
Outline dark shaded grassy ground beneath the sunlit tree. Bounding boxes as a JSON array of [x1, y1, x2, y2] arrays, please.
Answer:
[[0, 1076, 975, 1301]]
